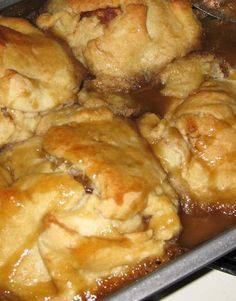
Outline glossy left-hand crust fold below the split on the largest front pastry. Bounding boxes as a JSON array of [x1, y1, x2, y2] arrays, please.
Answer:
[[0, 174, 83, 300]]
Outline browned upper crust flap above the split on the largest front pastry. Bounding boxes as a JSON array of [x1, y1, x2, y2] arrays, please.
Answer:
[[44, 109, 179, 218]]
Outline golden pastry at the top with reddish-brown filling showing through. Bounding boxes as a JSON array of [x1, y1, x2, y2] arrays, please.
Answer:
[[37, 0, 201, 92]]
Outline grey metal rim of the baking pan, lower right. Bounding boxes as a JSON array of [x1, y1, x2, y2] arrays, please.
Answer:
[[0, 0, 236, 301]]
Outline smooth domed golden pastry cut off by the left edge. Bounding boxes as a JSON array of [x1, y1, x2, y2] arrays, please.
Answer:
[[0, 17, 84, 145]]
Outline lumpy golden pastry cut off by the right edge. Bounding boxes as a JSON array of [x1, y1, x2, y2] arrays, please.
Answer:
[[139, 76, 236, 215]]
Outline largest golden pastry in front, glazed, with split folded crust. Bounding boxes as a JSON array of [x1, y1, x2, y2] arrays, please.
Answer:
[[0, 108, 181, 301]]
